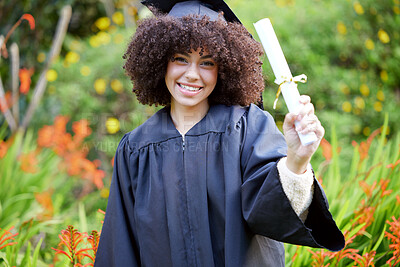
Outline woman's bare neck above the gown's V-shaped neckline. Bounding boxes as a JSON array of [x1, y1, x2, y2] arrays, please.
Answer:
[[171, 101, 210, 135]]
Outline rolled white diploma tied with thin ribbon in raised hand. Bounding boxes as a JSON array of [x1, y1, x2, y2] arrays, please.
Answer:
[[254, 18, 317, 146]]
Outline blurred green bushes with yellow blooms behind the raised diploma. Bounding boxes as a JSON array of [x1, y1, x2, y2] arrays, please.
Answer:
[[227, 0, 400, 141]]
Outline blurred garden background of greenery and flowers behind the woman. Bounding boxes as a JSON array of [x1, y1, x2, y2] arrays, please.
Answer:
[[0, 0, 400, 266]]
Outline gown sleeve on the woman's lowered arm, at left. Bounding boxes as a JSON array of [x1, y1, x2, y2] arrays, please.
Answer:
[[94, 134, 140, 267]]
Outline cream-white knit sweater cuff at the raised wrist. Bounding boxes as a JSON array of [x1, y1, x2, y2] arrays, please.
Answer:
[[278, 157, 314, 222]]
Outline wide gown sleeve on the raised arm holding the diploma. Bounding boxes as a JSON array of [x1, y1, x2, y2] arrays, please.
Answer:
[[241, 106, 344, 251]]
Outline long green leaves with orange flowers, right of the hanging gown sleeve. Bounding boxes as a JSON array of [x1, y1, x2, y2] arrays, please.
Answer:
[[286, 115, 400, 266]]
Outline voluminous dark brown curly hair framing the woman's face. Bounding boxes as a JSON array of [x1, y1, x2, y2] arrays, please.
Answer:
[[123, 12, 264, 106]]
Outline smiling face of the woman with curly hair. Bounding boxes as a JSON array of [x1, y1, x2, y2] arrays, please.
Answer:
[[165, 48, 218, 112]]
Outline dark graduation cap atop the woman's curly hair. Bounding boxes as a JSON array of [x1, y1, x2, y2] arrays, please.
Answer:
[[141, 0, 241, 23]]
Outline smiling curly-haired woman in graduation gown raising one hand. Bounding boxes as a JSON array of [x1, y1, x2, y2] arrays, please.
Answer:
[[95, 1, 344, 266]]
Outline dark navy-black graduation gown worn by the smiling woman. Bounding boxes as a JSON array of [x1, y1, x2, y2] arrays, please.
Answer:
[[95, 105, 344, 267]]
